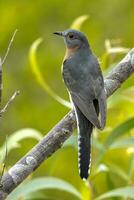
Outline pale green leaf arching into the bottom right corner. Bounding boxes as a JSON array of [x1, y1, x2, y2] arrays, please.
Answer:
[[95, 186, 134, 200]]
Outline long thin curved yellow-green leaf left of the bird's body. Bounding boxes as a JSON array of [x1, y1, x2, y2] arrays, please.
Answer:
[[29, 38, 72, 108]]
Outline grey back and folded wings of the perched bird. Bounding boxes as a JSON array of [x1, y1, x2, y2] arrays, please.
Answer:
[[63, 53, 106, 129]]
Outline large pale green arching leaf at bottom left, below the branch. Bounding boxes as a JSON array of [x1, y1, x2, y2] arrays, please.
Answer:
[[7, 177, 82, 200]]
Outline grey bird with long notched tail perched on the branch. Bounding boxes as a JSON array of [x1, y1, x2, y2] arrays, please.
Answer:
[[54, 29, 107, 180]]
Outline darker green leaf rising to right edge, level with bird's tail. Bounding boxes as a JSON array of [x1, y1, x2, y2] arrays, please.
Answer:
[[104, 117, 134, 146]]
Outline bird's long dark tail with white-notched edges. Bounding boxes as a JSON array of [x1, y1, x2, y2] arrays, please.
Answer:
[[75, 104, 93, 179]]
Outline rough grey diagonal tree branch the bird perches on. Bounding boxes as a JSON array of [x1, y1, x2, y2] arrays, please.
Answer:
[[0, 49, 134, 200]]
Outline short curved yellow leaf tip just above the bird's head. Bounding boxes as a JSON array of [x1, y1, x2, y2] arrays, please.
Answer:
[[70, 15, 89, 30]]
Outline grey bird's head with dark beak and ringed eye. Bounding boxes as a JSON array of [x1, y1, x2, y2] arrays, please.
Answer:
[[54, 29, 89, 49]]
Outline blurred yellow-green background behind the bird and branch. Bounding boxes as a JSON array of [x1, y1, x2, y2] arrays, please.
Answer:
[[0, 0, 134, 200]]
